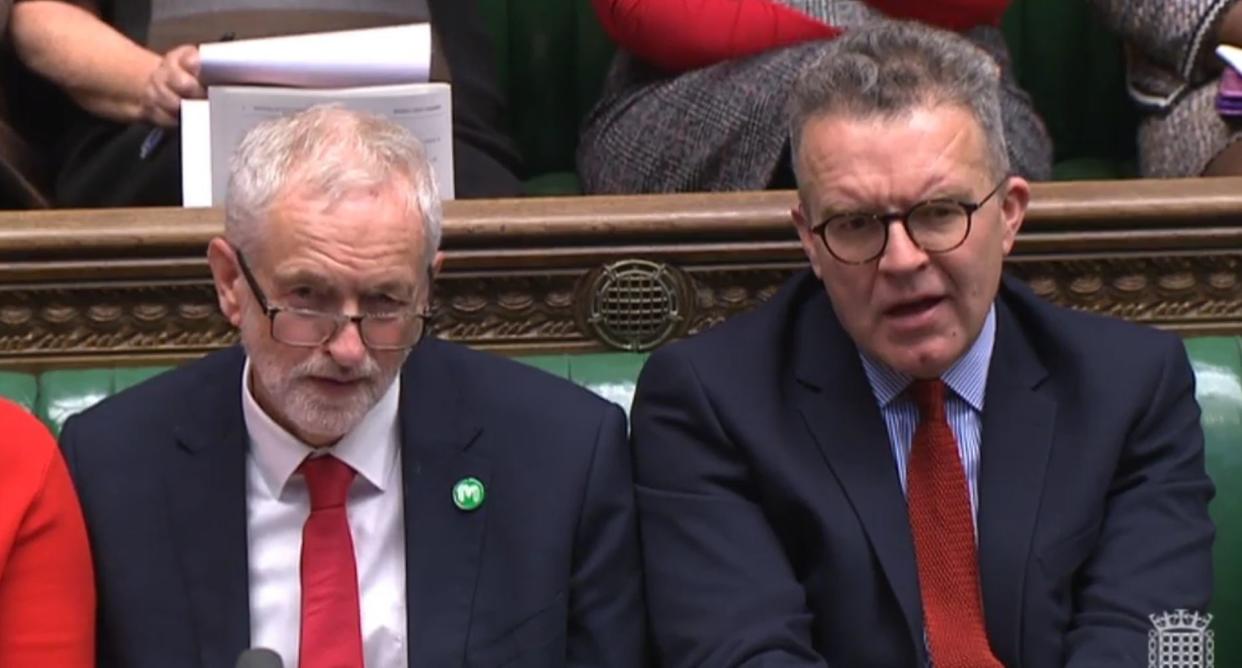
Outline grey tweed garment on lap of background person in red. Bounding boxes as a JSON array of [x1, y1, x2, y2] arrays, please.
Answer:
[[578, 0, 1052, 194]]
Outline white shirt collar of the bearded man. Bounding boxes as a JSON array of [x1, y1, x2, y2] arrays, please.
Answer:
[[241, 358, 401, 498]]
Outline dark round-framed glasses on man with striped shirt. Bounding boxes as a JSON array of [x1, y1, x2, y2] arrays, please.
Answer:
[[811, 176, 1010, 264]]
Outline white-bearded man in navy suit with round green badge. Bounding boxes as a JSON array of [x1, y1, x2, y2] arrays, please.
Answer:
[[62, 107, 643, 668]]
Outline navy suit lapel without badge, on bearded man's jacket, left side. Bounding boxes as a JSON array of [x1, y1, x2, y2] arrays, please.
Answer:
[[164, 349, 250, 667]]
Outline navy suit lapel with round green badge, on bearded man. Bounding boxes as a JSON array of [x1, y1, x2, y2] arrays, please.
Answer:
[[400, 340, 492, 666]]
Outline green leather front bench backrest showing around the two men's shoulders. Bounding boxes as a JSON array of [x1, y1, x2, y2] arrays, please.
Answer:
[[0, 336, 1242, 667]]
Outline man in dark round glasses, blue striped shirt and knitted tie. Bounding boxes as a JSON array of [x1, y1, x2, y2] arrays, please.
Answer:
[[632, 24, 1213, 668]]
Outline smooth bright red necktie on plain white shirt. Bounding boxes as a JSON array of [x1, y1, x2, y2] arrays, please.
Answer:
[[298, 456, 363, 668]]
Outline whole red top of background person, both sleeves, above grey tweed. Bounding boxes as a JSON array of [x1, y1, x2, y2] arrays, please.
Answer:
[[591, 0, 1009, 72]]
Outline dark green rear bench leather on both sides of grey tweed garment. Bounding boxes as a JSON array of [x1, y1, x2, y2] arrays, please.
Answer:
[[478, 0, 1136, 195]]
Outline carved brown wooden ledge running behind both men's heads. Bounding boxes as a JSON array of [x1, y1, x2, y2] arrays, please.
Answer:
[[0, 179, 1242, 368]]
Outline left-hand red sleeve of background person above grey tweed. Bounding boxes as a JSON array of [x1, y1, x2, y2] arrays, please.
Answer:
[[591, 0, 841, 72]]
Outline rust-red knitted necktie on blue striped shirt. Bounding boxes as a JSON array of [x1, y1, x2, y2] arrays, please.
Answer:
[[905, 380, 1002, 668]]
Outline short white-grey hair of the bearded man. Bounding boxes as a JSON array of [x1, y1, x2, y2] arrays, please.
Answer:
[[225, 104, 443, 266]]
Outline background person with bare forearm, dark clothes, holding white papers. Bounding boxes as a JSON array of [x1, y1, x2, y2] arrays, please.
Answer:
[[11, 0, 520, 207]]
